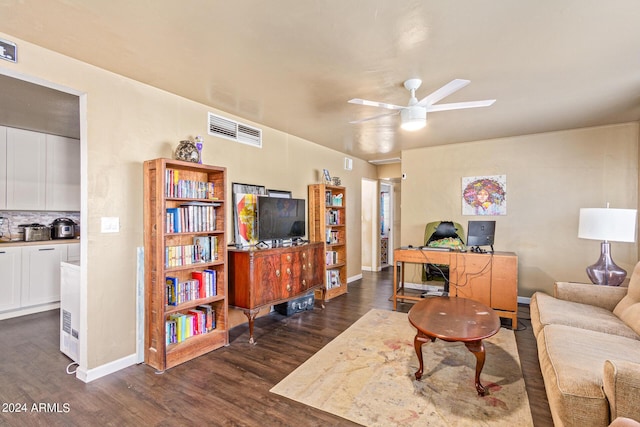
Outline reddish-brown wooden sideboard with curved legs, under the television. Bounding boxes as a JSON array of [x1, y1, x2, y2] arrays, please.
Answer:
[[227, 242, 324, 344]]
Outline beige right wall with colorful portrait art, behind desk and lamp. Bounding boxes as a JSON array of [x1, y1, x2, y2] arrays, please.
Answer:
[[401, 123, 638, 297]]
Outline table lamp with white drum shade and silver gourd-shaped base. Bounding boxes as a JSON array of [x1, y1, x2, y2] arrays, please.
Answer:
[[578, 203, 637, 286]]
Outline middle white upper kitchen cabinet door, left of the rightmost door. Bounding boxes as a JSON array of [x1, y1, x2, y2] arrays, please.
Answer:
[[6, 128, 47, 210]]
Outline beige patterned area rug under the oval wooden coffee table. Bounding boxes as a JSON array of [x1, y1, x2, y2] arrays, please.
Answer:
[[271, 309, 533, 427]]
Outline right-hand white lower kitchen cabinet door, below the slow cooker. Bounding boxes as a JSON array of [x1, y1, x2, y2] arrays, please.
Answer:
[[21, 244, 67, 307]]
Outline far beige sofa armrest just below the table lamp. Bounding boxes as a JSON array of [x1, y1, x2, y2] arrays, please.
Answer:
[[553, 282, 629, 311]]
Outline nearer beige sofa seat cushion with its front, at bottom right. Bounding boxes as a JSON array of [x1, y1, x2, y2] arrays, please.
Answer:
[[538, 325, 640, 426]]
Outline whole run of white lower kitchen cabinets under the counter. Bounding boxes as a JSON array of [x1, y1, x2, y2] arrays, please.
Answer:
[[0, 243, 80, 318]]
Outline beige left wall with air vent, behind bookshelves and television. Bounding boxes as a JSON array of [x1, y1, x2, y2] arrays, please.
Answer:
[[0, 33, 376, 369]]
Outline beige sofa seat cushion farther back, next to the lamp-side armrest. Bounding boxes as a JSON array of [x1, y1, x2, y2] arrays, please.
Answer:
[[530, 292, 640, 340]]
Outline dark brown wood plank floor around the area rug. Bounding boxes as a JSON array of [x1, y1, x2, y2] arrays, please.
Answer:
[[0, 271, 553, 427]]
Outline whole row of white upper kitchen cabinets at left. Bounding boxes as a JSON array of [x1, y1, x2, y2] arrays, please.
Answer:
[[0, 127, 80, 211]]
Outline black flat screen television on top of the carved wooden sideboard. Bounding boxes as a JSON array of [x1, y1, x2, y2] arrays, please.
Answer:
[[256, 197, 307, 241]]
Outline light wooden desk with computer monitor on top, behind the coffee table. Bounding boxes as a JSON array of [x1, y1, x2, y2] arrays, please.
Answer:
[[393, 248, 518, 329]]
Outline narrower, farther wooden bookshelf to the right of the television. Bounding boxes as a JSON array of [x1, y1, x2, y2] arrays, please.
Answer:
[[309, 184, 347, 300]]
